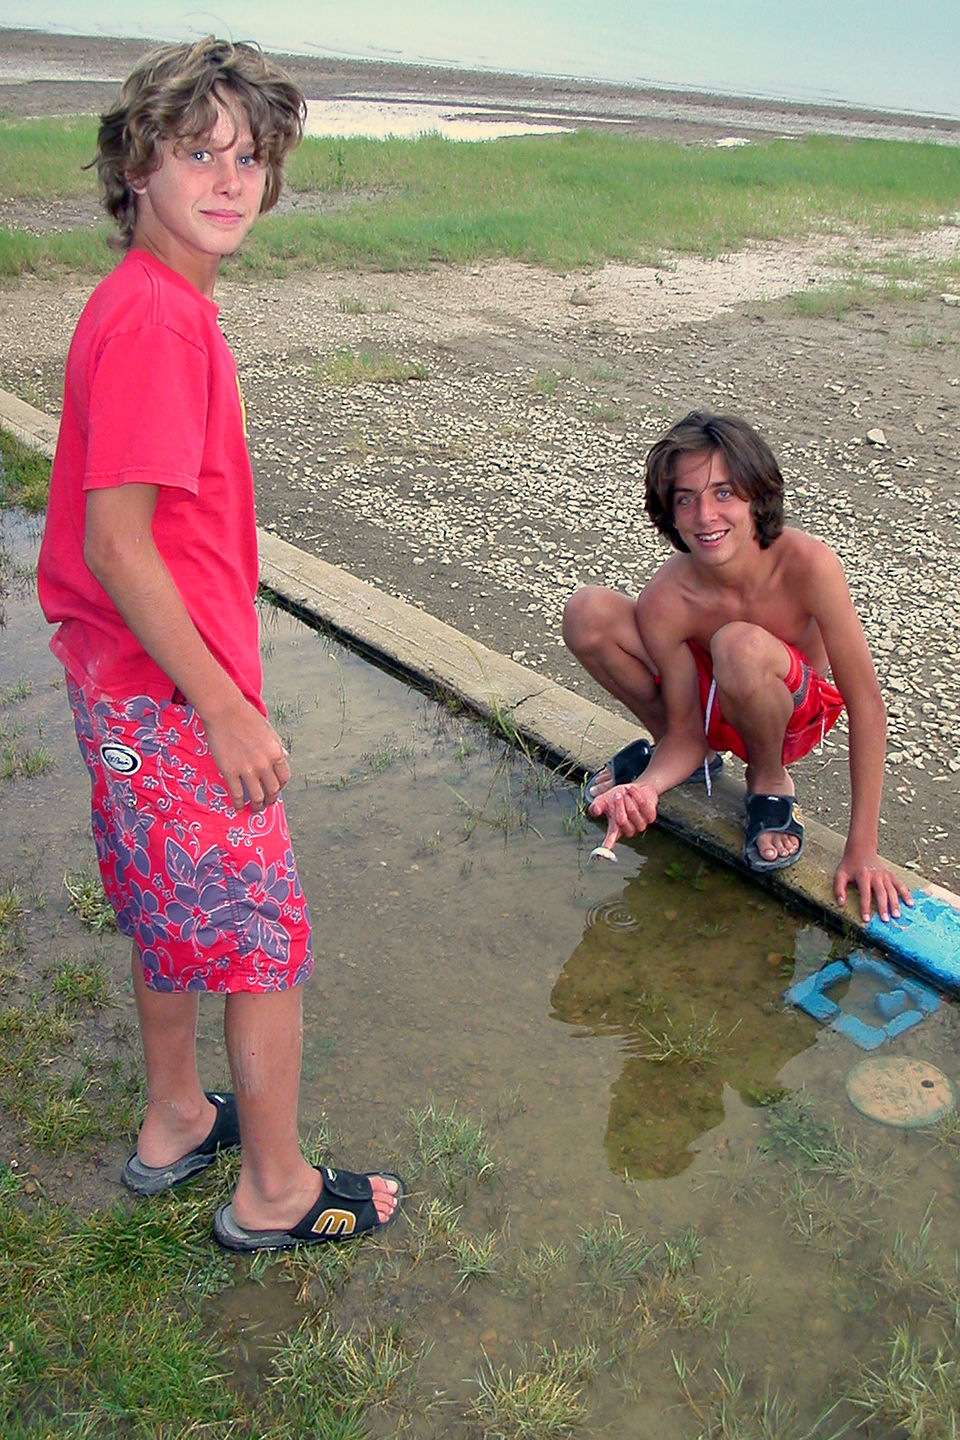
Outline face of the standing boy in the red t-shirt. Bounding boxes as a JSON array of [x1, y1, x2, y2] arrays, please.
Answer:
[[134, 101, 266, 295]]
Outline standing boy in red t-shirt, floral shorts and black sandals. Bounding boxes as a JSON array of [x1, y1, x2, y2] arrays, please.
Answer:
[[39, 37, 403, 1250]]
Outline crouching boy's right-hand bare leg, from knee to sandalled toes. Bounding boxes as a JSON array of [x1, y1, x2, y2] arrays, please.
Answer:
[[711, 621, 800, 860]]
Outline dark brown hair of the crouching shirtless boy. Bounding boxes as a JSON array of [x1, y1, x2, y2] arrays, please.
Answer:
[[645, 410, 783, 553]]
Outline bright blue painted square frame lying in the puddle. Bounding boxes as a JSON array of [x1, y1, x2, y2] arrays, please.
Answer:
[[783, 950, 940, 1050]]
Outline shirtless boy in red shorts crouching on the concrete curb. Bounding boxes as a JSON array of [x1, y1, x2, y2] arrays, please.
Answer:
[[563, 410, 913, 922]]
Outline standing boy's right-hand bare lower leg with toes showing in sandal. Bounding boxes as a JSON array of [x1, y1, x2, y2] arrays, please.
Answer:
[[225, 985, 397, 1230]]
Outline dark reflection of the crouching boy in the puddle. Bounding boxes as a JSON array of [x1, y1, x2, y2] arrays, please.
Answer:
[[551, 844, 815, 1178]]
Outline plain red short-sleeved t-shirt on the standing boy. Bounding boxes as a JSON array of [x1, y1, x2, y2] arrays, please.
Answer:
[[37, 251, 263, 710]]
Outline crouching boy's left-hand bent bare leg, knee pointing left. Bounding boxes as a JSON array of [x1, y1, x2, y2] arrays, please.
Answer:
[[563, 585, 666, 740]]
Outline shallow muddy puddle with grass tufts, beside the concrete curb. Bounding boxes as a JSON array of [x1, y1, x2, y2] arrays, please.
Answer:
[[0, 517, 960, 1440]]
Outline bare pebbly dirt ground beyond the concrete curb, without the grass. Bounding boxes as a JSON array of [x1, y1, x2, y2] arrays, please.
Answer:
[[0, 30, 960, 890]]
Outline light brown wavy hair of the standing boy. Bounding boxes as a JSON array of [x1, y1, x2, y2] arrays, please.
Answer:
[[92, 35, 307, 249]]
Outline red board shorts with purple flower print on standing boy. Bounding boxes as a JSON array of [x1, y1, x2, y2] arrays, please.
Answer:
[[68, 678, 314, 992]]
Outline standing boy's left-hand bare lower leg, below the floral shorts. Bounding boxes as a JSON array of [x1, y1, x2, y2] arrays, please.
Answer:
[[132, 946, 217, 1166]]
